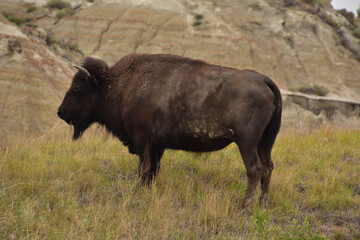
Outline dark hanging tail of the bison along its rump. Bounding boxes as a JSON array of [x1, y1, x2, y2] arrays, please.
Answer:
[[258, 78, 282, 165]]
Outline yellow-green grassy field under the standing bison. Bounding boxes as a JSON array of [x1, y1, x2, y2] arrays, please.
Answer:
[[0, 124, 360, 239]]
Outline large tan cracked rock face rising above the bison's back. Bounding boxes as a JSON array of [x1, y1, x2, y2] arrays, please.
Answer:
[[45, 0, 360, 100]]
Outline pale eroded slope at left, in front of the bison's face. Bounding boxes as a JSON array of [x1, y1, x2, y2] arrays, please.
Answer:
[[0, 15, 74, 141]]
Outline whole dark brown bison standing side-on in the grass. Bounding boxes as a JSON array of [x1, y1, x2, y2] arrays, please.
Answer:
[[58, 54, 282, 207]]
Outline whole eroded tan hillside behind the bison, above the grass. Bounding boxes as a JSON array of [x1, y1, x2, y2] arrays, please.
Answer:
[[0, 0, 360, 141]]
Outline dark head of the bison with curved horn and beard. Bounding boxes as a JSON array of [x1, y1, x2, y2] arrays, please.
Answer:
[[58, 58, 108, 140]]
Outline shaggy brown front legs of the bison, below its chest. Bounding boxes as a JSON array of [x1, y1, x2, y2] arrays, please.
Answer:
[[138, 141, 164, 185]]
